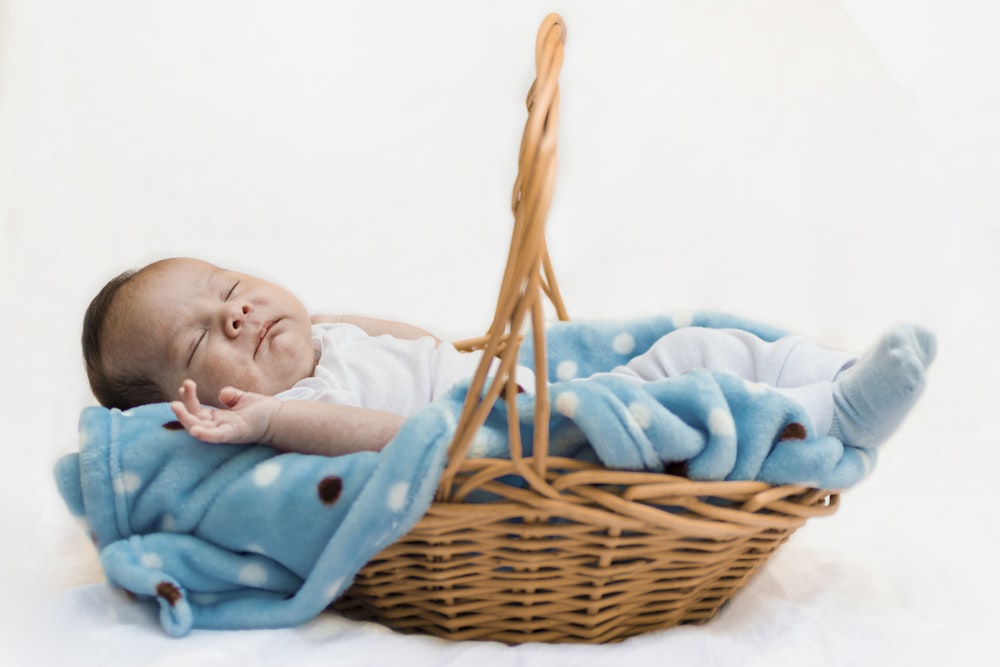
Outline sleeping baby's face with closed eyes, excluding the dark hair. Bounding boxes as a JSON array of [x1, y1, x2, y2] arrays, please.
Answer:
[[108, 259, 316, 405]]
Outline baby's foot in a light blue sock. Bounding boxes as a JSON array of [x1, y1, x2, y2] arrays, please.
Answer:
[[830, 324, 937, 447]]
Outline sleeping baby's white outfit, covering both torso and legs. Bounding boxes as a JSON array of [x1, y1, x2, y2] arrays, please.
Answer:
[[277, 323, 855, 432]]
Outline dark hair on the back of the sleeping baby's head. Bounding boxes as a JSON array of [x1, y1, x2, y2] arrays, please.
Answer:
[[81, 269, 166, 410]]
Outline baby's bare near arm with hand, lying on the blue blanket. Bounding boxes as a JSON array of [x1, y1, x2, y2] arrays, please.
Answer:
[[170, 380, 403, 456]]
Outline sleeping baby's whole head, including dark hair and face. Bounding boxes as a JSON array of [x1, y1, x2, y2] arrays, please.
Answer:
[[83, 258, 316, 409]]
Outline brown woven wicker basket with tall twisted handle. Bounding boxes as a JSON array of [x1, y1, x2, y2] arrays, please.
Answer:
[[334, 14, 838, 643]]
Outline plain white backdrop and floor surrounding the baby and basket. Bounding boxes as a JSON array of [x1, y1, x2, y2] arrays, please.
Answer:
[[0, 0, 1000, 666]]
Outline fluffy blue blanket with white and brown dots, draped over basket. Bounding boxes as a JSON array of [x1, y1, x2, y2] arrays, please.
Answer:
[[55, 313, 875, 636]]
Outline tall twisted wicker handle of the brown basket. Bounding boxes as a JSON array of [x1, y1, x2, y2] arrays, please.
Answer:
[[438, 14, 568, 501]]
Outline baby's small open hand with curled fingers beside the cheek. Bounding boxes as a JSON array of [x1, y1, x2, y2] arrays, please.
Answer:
[[170, 380, 281, 444]]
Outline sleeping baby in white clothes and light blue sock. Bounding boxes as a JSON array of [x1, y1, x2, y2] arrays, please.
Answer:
[[83, 258, 935, 456]]
